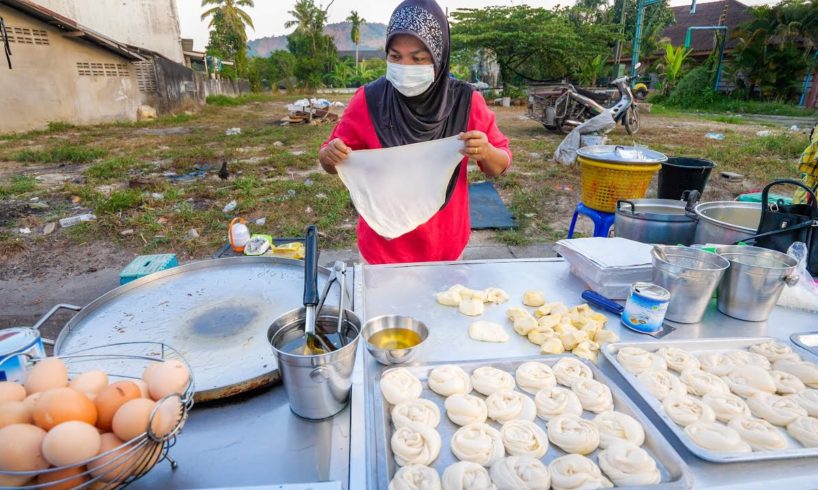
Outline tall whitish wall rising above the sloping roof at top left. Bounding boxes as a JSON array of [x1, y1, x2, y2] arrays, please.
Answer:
[[34, 0, 185, 64]]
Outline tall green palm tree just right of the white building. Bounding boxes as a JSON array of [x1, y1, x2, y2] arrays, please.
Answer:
[[201, 0, 254, 76]]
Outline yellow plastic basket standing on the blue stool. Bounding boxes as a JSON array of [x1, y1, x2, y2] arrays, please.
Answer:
[[578, 156, 662, 213]]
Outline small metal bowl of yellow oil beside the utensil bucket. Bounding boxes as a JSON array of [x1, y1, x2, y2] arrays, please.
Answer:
[[361, 315, 429, 366]]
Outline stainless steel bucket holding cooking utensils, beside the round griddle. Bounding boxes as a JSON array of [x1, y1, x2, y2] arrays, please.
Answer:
[[267, 306, 361, 420]]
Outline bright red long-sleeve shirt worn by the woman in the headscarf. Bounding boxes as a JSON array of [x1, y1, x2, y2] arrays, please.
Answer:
[[324, 88, 511, 264]]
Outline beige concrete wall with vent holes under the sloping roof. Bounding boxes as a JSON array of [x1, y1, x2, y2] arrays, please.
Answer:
[[0, 5, 141, 133]]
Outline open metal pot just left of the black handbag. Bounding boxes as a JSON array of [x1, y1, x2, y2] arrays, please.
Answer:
[[694, 201, 761, 245]]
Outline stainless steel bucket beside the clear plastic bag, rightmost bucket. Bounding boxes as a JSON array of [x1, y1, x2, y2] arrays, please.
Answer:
[[718, 246, 798, 322]]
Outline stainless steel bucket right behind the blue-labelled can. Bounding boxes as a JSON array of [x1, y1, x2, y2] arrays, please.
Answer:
[[652, 247, 730, 323]]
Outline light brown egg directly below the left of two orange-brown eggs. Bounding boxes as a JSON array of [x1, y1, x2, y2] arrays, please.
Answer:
[[43, 420, 102, 466]]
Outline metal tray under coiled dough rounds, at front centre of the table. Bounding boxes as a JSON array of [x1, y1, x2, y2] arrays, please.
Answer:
[[366, 355, 693, 489]]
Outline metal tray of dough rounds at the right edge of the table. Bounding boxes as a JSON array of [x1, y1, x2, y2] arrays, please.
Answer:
[[602, 337, 818, 463]]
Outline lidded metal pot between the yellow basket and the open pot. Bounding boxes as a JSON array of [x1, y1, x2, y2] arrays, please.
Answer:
[[614, 199, 698, 245]]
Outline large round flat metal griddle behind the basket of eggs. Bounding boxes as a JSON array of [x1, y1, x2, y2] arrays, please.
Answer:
[[54, 257, 338, 401]]
